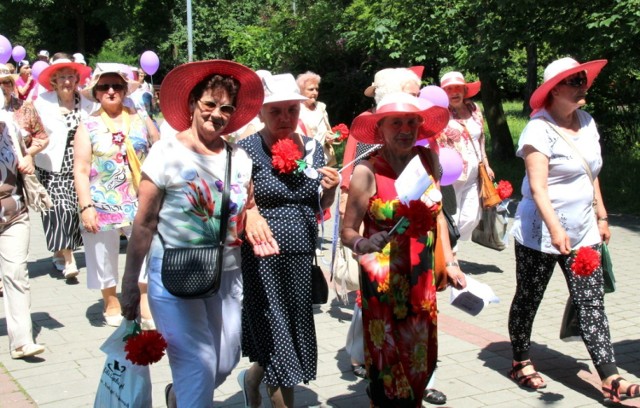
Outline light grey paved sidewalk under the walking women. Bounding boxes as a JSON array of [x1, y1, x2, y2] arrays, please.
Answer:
[[0, 214, 640, 408]]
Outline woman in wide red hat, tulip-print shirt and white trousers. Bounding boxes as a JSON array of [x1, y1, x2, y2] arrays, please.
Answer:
[[122, 60, 269, 407]]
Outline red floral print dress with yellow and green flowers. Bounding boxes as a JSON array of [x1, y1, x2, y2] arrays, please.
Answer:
[[360, 153, 441, 407]]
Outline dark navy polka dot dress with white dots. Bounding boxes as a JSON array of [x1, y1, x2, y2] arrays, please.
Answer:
[[238, 133, 324, 387]]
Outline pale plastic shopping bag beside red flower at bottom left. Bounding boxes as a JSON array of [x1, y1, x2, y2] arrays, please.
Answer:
[[93, 320, 152, 408]]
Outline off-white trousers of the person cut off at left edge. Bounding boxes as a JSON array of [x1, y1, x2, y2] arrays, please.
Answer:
[[0, 214, 33, 350]]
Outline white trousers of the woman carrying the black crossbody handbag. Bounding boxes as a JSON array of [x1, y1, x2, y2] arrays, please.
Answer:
[[149, 257, 242, 408]]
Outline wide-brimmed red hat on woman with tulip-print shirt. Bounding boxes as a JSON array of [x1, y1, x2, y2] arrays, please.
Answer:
[[160, 60, 264, 134]]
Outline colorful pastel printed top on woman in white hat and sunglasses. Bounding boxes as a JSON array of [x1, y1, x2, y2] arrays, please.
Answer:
[[83, 111, 149, 231]]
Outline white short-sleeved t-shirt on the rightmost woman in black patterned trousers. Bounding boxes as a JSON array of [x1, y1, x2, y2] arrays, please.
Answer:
[[511, 110, 602, 254]]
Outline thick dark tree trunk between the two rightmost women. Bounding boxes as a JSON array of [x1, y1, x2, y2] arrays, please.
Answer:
[[480, 71, 516, 160]]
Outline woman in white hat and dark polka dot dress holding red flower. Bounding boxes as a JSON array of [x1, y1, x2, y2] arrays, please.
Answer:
[[238, 74, 339, 408]]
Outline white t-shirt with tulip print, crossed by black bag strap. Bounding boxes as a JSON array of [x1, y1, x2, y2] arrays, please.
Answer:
[[142, 138, 252, 269]]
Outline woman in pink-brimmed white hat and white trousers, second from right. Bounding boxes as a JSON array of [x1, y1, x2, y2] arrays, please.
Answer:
[[438, 71, 494, 250]]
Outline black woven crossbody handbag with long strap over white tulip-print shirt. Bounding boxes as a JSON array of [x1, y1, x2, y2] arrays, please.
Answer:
[[158, 143, 231, 299]]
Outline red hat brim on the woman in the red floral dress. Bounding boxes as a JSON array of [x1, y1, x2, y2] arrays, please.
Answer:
[[349, 104, 449, 144]]
